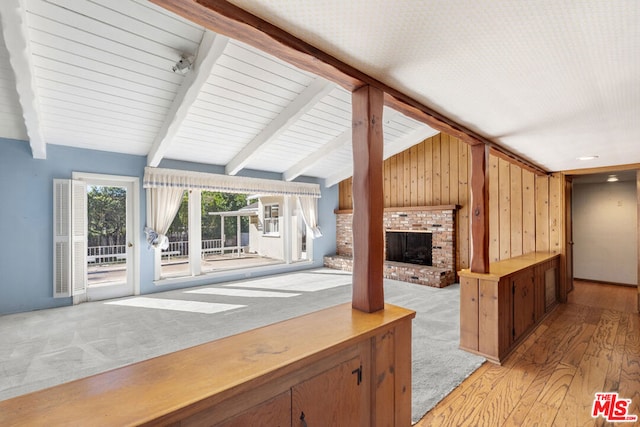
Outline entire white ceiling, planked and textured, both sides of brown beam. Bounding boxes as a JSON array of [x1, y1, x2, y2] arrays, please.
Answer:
[[0, 0, 640, 185]]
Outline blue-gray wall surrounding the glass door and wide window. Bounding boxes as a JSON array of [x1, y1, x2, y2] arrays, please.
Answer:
[[0, 138, 338, 314]]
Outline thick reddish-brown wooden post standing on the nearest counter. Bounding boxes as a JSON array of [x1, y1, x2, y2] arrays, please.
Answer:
[[352, 86, 384, 313]]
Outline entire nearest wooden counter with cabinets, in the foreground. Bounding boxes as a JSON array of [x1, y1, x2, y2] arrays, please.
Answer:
[[0, 303, 415, 426]]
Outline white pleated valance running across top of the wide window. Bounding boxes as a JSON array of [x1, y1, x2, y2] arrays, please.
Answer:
[[144, 167, 320, 198]]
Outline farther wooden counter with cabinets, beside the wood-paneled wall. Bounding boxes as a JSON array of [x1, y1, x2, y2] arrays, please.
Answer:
[[459, 252, 560, 363]]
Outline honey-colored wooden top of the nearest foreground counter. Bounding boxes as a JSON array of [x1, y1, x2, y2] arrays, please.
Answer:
[[0, 303, 415, 426]]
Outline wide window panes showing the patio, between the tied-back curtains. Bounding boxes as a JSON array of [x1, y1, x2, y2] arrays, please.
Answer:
[[155, 194, 313, 280]]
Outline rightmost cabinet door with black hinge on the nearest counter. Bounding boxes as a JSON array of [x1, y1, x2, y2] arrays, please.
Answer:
[[291, 357, 367, 427]]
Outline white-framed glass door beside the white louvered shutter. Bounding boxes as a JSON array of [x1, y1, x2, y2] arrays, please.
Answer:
[[73, 173, 140, 302]]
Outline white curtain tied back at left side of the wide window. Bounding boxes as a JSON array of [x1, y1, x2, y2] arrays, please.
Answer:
[[144, 187, 184, 249]]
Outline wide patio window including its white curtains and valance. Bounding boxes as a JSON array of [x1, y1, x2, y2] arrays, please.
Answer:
[[144, 167, 321, 280]]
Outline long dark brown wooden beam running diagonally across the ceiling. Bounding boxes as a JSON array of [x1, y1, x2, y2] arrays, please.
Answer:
[[150, 0, 548, 174]]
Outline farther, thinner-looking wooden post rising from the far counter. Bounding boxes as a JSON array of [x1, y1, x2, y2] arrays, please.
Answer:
[[470, 144, 489, 273]]
